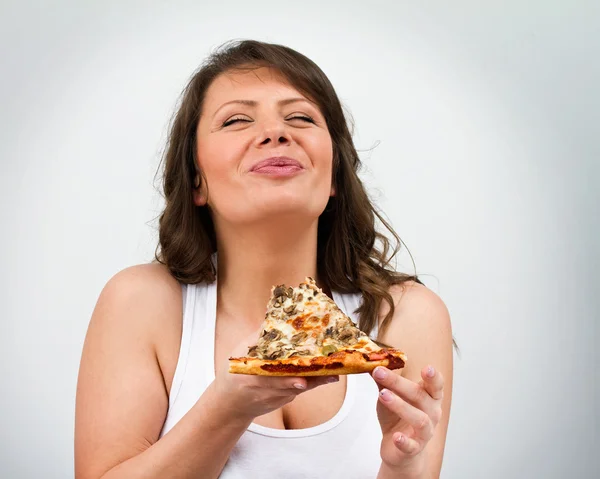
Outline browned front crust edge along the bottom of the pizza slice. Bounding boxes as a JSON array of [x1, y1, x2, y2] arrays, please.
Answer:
[[229, 349, 406, 376]]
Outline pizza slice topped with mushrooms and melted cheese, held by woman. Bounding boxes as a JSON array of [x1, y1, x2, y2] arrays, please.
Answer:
[[229, 278, 406, 376]]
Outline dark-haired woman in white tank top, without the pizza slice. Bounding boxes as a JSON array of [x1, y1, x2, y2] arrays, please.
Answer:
[[75, 41, 452, 479]]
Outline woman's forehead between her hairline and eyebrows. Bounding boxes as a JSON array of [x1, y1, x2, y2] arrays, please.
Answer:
[[204, 67, 308, 111]]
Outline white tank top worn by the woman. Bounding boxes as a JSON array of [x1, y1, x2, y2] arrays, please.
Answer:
[[161, 281, 382, 479]]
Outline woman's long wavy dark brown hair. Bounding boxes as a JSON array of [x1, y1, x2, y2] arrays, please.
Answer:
[[156, 40, 420, 342]]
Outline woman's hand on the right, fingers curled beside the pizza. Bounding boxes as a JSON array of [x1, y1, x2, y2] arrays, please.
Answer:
[[373, 366, 444, 477]]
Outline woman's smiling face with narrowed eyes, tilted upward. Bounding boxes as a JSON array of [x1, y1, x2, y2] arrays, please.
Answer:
[[194, 67, 333, 228]]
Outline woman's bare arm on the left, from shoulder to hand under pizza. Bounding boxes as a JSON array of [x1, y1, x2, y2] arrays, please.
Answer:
[[75, 265, 332, 479]]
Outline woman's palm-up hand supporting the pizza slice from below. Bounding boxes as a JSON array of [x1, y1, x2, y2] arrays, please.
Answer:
[[213, 330, 339, 421]]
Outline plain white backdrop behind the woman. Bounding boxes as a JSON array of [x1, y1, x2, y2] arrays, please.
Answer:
[[0, 0, 600, 479]]
